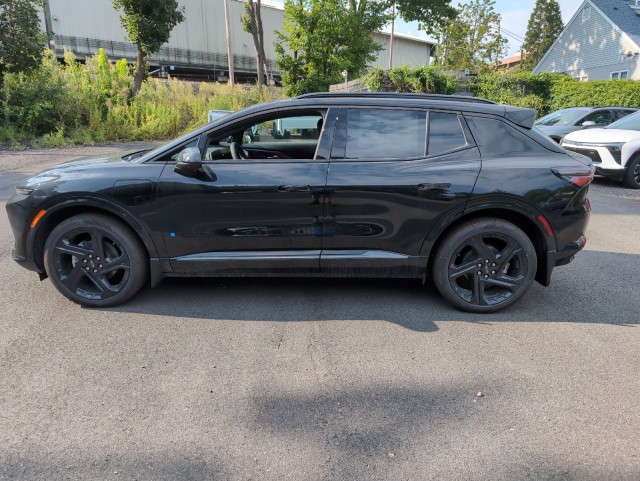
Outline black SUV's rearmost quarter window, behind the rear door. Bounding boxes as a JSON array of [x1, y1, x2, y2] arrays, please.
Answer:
[[465, 116, 548, 157]]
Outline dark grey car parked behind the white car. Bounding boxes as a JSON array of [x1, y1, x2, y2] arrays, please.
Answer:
[[534, 107, 638, 143]]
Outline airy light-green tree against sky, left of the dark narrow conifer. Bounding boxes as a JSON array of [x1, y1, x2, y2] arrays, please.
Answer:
[[435, 0, 508, 72]]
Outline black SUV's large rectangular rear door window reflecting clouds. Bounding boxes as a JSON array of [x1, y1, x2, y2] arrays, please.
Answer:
[[345, 109, 427, 159]]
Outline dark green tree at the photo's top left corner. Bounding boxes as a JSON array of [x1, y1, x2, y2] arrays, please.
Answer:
[[0, 0, 46, 83]]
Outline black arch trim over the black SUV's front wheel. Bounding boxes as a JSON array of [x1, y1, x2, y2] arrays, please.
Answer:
[[26, 199, 159, 273]]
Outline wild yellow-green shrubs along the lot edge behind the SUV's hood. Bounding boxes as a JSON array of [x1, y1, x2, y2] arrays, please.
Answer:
[[0, 50, 282, 146]]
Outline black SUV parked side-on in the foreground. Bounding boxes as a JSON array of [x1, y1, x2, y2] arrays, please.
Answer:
[[7, 94, 593, 312]]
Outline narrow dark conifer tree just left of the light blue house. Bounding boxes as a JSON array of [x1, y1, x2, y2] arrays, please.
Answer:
[[522, 0, 564, 70]]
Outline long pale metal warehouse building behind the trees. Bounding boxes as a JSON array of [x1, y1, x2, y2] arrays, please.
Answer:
[[43, 0, 434, 81]]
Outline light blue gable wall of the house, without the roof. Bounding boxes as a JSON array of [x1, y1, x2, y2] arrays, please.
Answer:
[[533, 2, 640, 80]]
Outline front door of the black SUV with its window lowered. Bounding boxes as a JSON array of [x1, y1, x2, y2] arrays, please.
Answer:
[[157, 108, 328, 275]]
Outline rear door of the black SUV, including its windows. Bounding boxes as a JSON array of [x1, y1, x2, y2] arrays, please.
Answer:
[[320, 107, 480, 277]]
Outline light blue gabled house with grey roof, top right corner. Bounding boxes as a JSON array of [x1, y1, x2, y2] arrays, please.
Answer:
[[533, 0, 640, 81]]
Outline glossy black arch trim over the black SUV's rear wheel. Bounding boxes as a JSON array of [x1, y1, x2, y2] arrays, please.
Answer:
[[421, 202, 556, 285]]
